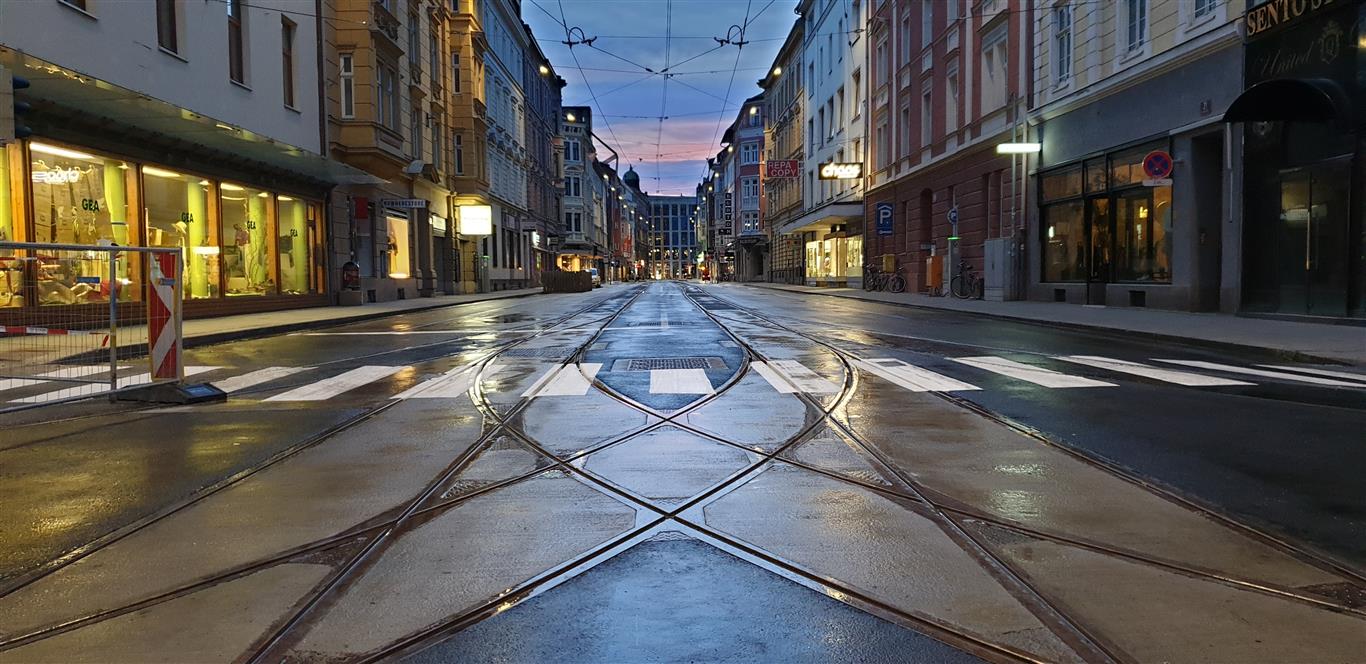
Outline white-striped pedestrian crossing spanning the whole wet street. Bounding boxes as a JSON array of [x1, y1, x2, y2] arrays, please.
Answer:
[[0, 355, 1366, 403]]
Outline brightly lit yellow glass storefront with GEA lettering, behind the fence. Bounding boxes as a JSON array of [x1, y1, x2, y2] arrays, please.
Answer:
[[0, 141, 322, 307]]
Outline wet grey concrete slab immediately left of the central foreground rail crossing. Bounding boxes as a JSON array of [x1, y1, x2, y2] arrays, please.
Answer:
[[291, 471, 635, 660]]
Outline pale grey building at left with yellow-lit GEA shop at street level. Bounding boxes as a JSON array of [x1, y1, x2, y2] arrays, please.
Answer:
[[0, 0, 365, 320]]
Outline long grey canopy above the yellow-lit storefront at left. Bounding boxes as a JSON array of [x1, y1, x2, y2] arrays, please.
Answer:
[[0, 48, 385, 184]]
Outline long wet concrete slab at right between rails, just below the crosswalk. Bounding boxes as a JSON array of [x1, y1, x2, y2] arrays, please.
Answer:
[[837, 377, 1341, 587]]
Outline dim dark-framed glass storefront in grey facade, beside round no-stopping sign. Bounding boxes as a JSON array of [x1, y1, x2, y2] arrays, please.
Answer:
[[1040, 143, 1173, 291]]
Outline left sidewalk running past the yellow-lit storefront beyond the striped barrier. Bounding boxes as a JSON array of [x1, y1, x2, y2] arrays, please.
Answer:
[[178, 287, 541, 347]]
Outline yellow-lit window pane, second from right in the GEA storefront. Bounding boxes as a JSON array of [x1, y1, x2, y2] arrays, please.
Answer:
[[219, 182, 276, 296]]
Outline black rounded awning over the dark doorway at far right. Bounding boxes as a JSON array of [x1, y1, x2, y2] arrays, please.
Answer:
[[1224, 78, 1351, 123]]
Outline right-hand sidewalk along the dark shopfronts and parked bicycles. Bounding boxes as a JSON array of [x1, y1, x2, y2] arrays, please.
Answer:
[[743, 283, 1366, 365]]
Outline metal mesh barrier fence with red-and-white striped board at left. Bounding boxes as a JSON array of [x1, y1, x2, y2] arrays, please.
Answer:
[[0, 242, 184, 413]]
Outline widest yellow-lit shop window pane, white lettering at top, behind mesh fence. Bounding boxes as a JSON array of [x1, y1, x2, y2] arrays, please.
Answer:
[[29, 142, 138, 305]]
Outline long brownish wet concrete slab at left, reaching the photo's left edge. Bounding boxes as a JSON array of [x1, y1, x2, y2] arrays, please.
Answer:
[[0, 400, 482, 637]]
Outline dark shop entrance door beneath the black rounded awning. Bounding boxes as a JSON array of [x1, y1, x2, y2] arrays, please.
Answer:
[[1276, 161, 1351, 316]]
